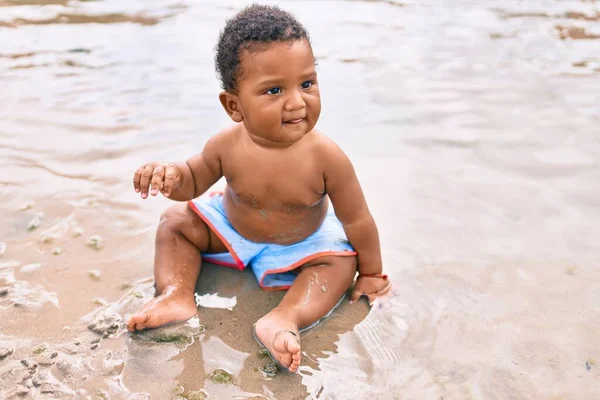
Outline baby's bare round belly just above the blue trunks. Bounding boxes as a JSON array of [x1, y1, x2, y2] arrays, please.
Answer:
[[223, 191, 328, 245]]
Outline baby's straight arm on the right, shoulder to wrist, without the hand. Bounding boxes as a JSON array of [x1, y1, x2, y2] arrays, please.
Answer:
[[322, 138, 383, 275]]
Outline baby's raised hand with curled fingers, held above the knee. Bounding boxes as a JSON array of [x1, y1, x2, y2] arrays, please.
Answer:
[[133, 162, 181, 199]]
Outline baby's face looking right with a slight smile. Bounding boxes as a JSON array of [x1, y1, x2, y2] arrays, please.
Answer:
[[238, 40, 321, 146]]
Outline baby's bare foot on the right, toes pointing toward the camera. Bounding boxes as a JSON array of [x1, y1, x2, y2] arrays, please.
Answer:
[[255, 313, 301, 372]]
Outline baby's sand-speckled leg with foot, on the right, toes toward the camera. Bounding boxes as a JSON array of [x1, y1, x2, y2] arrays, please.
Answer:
[[256, 256, 357, 372]]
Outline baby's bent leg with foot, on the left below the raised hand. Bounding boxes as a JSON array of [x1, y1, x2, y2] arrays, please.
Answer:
[[127, 203, 227, 331]]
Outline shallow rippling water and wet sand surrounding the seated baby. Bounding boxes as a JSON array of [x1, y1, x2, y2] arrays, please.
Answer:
[[0, 0, 600, 400]]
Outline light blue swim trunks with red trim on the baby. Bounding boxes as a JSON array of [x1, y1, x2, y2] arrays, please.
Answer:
[[189, 193, 356, 290]]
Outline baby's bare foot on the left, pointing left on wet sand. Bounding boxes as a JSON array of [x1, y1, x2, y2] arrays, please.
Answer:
[[127, 287, 197, 332]]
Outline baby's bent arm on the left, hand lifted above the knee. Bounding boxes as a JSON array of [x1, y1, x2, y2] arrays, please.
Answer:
[[133, 134, 226, 201]]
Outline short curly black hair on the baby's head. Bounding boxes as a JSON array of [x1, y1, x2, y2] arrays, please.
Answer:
[[215, 4, 310, 93]]
